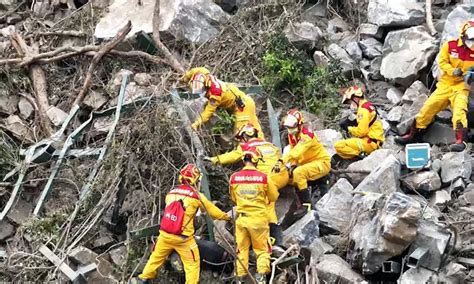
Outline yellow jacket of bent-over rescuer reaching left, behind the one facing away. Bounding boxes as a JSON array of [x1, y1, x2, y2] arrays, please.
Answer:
[[211, 138, 281, 174]]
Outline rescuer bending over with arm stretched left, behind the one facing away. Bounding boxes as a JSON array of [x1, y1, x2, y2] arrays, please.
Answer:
[[205, 123, 289, 254]]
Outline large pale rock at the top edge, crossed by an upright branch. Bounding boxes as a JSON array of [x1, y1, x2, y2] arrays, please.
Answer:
[[94, 0, 229, 43]]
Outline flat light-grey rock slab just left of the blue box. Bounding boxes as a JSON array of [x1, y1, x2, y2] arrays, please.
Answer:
[[347, 149, 397, 186]]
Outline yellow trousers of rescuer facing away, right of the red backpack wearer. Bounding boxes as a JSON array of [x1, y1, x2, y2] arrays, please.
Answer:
[[235, 213, 272, 277]]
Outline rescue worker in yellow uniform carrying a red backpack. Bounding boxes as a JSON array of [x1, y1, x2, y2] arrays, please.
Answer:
[[138, 164, 230, 283]]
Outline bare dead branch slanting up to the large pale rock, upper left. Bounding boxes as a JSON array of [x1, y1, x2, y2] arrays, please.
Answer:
[[74, 21, 132, 104]]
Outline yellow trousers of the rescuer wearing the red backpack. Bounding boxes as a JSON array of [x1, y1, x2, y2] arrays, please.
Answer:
[[138, 231, 201, 284]]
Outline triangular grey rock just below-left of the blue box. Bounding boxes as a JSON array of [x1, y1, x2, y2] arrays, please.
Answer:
[[355, 155, 401, 194]]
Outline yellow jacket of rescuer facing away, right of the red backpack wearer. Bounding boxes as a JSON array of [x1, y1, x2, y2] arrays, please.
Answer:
[[229, 166, 278, 219]]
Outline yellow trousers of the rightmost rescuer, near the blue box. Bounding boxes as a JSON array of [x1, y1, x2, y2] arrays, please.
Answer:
[[416, 81, 469, 129]]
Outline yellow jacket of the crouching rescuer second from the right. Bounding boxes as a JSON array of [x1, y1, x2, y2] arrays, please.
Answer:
[[348, 100, 385, 143]]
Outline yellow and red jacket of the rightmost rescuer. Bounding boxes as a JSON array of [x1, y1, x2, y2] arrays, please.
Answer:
[[438, 39, 474, 88]]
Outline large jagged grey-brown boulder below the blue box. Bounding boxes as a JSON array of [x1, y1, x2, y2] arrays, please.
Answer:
[[347, 192, 421, 274]]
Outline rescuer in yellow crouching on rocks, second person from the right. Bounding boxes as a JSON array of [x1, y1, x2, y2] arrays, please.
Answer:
[[334, 86, 385, 159]]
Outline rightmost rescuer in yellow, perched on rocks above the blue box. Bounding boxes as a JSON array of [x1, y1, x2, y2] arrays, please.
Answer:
[[396, 20, 474, 152]]
